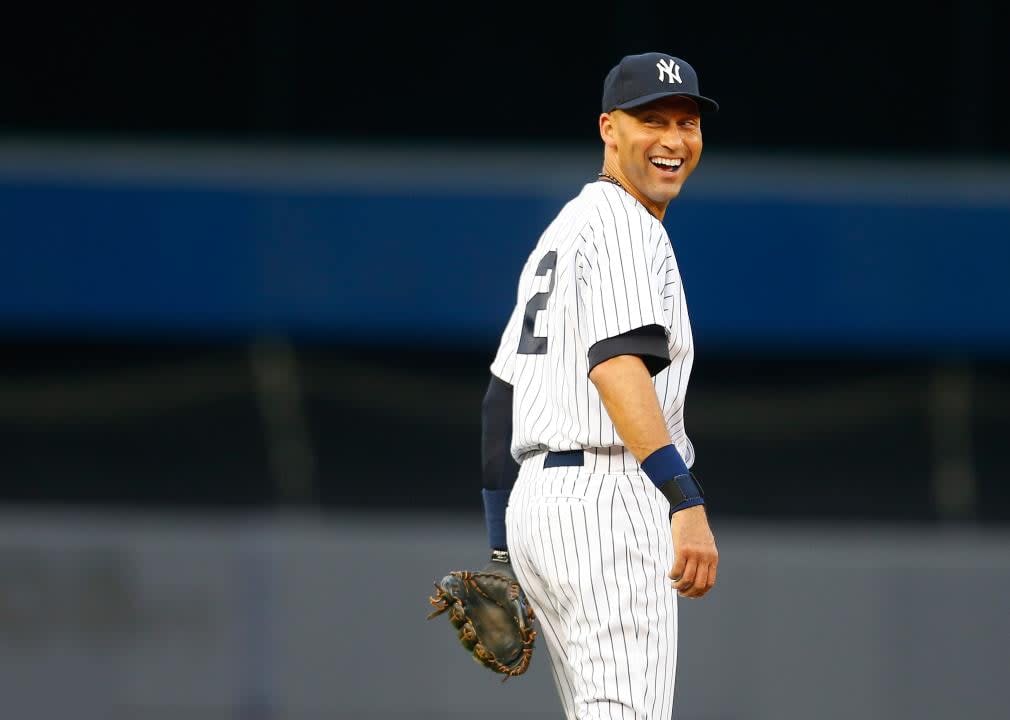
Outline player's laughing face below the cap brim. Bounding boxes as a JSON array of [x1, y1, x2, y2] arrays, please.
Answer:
[[605, 96, 702, 207]]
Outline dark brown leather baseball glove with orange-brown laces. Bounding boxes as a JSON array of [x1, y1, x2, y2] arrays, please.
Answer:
[[428, 561, 536, 682]]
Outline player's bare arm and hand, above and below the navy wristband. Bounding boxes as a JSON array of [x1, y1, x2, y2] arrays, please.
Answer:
[[589, 354, 719, 598]]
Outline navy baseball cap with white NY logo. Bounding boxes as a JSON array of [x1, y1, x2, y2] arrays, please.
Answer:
[[603, 53, 719, 112]]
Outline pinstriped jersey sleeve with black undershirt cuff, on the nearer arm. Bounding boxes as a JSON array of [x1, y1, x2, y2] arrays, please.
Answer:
[[577, 193, 670, 376]]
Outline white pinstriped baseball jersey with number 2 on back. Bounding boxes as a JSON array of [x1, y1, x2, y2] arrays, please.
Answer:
[[491, 181, 694, 470]]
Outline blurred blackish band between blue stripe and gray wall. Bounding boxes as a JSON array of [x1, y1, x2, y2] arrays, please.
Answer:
[[0, 340, 1010, 523]]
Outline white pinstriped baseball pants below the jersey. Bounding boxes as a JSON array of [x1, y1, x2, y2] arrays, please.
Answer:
[[506, 448, 677, 720]]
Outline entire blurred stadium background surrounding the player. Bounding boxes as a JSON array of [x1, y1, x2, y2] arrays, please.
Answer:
[[0, 0, 1010, 720]]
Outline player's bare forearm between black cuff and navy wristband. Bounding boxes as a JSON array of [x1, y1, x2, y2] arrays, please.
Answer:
[[589, 355, 671, 462]]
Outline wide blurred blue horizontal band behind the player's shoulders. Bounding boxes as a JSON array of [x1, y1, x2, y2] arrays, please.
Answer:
[[0, 176, 1010, 352]]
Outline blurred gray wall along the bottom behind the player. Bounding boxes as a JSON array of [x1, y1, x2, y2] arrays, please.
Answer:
[[0, 504, 1010, 720]]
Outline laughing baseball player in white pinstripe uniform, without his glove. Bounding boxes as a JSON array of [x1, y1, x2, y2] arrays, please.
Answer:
[[482, 53, 718, 720]]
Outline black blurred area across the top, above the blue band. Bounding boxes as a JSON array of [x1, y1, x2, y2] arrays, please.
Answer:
[[0, 0, 1010, 157]]
